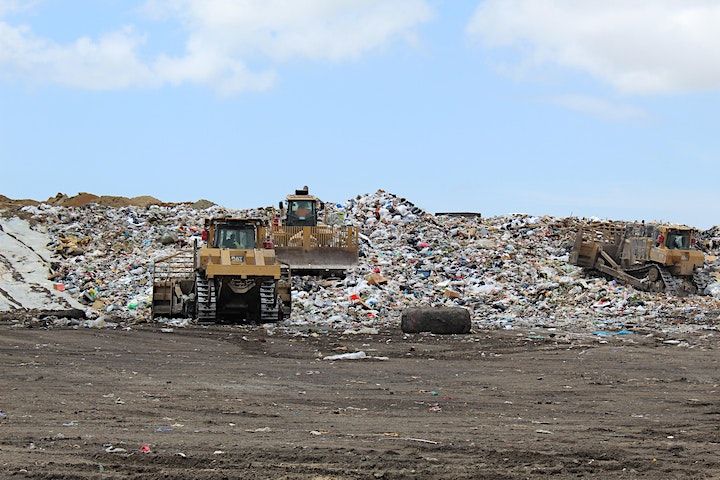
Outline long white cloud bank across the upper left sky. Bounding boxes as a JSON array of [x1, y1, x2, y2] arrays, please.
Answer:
[[0, 0, 431, 94]]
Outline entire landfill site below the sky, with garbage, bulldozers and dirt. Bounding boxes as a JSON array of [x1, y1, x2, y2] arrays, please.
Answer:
[[0, 186, 720, 480]]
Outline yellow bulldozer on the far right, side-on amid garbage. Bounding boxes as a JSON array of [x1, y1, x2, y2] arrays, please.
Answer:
[[570, 222, 707, 295]]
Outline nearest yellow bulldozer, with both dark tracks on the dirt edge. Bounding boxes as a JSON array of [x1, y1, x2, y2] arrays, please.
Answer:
[[152, 217, 291, 323]]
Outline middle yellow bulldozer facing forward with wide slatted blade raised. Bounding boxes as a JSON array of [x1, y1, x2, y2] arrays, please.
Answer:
[[269, 187, 359, 275]]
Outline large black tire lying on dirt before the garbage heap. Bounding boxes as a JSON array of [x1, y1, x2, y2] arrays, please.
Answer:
[[400, 307, 472, 334]]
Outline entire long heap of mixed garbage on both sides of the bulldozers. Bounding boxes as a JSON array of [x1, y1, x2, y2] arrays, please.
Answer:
[[1, 190, 720, 333]]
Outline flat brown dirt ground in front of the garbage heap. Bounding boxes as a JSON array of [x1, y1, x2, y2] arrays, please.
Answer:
[[0, 326, 720, 480]]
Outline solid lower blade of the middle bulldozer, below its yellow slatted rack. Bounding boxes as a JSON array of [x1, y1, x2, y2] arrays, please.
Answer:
[[275, 247, 358, 274]]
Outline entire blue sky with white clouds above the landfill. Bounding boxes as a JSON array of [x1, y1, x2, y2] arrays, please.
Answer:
[[0, 0, 720, 227]]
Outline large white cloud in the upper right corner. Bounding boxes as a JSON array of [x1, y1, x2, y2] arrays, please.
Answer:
[[467, 0, 720, 94]]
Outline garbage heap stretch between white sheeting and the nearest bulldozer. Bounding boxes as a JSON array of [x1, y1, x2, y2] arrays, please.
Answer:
[[11, 201, 261, 320]]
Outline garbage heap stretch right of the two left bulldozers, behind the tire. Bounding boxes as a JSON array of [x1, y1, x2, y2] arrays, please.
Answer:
[[292, 191, 720, 331]]
